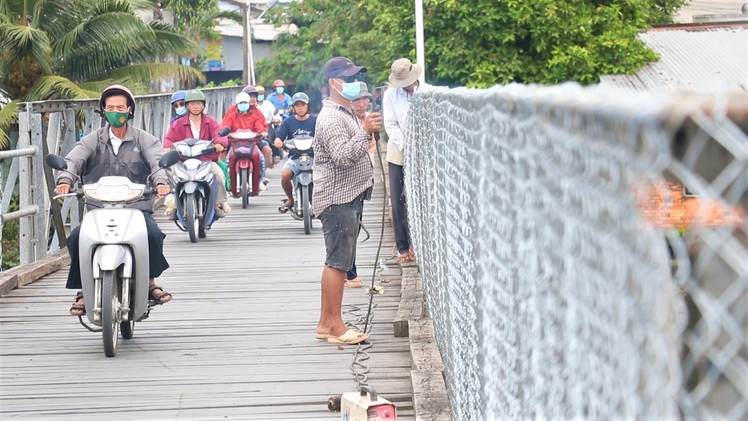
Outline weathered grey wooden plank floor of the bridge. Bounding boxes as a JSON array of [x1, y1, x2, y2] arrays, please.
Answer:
[[0, 159, 414, 420]]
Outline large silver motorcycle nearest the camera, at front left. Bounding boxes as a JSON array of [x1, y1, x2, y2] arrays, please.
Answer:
[[46, 152, 179, 357]]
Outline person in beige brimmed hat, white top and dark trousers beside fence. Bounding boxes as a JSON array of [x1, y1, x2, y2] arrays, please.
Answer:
[[382, 58, 423, 262]]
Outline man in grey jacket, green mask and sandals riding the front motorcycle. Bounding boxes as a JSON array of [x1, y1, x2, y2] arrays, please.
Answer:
[[55, 85, 172, 316]]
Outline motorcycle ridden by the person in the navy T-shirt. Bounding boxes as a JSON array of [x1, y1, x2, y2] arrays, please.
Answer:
[[284, 136, 314, 235]]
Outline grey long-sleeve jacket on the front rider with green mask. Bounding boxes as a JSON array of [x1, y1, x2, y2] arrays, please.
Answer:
[[57, 124, 169, 212]]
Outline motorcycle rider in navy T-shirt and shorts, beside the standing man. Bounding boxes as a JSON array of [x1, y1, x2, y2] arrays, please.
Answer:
[[275, 92, 317, 213]]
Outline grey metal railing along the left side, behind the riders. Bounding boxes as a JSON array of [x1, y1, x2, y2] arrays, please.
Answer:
[[0, 86, 241, 265]]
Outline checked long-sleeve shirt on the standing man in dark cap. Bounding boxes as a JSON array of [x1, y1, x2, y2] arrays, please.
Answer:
[[312, 100, 374, 215]]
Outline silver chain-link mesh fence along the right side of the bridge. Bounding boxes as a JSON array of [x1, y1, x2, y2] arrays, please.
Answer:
[[405, 84, 748, 420]]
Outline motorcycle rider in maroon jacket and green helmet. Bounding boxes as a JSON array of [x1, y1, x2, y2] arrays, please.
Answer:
[[164, 89, 231, 213]]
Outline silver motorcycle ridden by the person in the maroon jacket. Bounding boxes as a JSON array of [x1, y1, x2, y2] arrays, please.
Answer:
[[172, 128, 228, 243]]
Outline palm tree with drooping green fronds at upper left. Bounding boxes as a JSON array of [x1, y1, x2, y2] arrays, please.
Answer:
[[0, 0, 204, 149]]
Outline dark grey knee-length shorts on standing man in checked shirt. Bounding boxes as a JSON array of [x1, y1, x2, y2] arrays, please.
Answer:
[[319, 197, 364, 272]]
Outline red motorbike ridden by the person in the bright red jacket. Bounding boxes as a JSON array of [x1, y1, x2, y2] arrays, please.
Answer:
[[229, 130, 262, 209]]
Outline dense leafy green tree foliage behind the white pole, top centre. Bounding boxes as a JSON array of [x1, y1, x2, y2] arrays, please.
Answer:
[[257, 0, 684, 87]]
